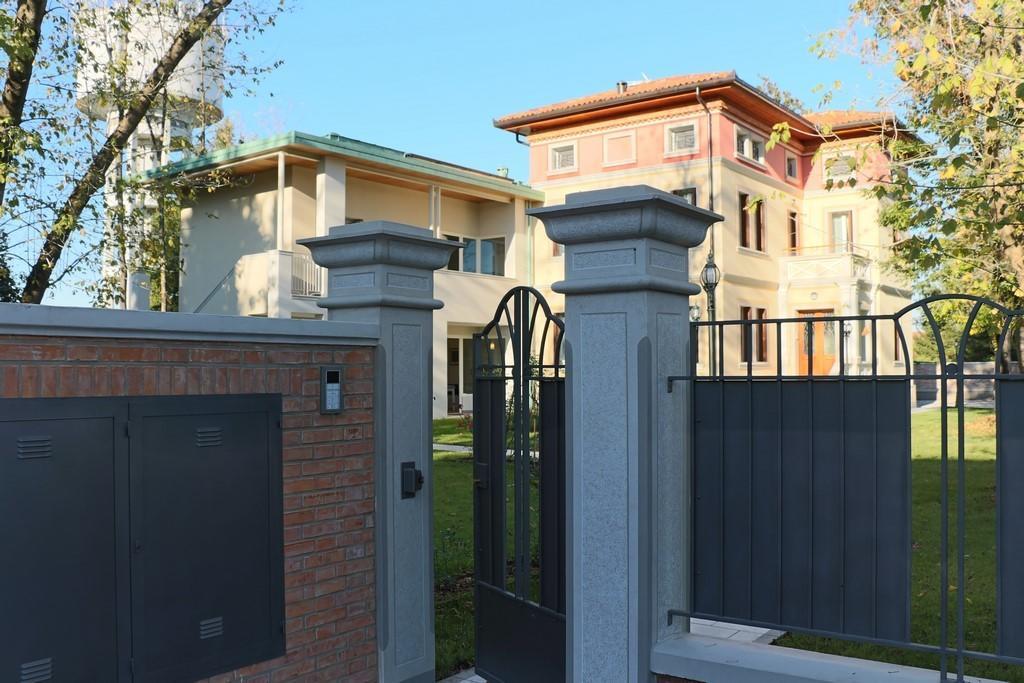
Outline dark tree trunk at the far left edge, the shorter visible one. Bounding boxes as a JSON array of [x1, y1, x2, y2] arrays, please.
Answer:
[[0, 0, 47, 206]]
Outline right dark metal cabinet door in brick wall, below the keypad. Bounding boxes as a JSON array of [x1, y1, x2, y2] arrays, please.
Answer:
[[130, 395, 285, 681]]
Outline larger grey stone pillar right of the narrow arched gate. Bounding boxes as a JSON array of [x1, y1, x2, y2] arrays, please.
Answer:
[[530, 185, 722, 683]]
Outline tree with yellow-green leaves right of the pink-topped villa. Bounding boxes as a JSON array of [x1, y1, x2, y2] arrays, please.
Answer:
[[831, 0, 1024, 315]]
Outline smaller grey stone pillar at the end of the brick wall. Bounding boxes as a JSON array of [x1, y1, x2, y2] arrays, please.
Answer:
[[301, 221, 458, 683]]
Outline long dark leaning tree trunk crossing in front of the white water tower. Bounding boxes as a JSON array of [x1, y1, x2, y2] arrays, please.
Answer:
[[22, 0, 231, 303]]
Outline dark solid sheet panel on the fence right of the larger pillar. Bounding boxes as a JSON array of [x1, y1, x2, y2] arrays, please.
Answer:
[[693, 379, 910, 640]]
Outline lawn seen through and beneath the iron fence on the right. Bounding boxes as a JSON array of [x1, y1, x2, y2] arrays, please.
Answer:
[[777, 410, 1024, 683]]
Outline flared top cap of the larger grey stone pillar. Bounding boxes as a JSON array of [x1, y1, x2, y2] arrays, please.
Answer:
[[527, 185, 725, 248]]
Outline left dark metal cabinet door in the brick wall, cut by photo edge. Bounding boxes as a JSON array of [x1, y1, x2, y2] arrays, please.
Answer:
[[0, 398, 130, 683]]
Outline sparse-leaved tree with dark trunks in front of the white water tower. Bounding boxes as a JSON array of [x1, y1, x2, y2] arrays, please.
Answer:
[[0, 0, 283, 303]]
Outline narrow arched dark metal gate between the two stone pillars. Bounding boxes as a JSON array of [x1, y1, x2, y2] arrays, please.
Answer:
[[473, 287, 565, 683]]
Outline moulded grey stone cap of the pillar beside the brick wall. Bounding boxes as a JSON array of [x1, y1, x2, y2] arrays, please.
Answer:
[[298, 220, 462, 309]]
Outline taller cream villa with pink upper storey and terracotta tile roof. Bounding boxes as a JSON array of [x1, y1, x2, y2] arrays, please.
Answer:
[[495, 72, 910, 374]]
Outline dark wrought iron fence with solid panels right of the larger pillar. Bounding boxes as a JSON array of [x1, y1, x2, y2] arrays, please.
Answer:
[[668, 295, 1024, 681]]
